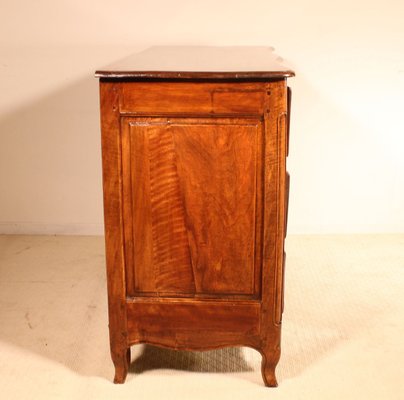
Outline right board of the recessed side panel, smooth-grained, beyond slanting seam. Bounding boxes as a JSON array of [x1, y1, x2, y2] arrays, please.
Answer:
[[172, 119, 260, 294]]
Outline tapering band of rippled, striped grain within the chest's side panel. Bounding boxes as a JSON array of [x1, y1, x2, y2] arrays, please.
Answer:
[[148, 126, 195, 293]]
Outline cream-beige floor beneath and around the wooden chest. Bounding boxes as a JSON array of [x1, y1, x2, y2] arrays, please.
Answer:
[[0, 235, 404, 400]]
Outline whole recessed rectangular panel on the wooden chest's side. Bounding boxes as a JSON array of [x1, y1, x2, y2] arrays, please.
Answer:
[[123, 118, 262, 295]]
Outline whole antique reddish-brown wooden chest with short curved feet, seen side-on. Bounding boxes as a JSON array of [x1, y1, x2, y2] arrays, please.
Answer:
[[96, 47, 293, 386]]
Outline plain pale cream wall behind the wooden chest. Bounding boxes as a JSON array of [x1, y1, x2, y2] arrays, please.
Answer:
[[0, 0, 404, 234]]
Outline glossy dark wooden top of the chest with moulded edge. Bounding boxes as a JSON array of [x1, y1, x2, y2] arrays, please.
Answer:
[[95, 46, 294, 80]]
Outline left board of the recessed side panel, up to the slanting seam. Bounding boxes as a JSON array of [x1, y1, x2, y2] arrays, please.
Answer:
[[124, 120, 195, 294]]
